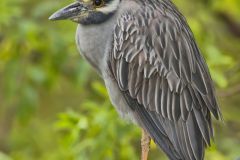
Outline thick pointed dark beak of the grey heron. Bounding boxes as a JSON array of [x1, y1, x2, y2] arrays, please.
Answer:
[[48, 2, 87, 20]]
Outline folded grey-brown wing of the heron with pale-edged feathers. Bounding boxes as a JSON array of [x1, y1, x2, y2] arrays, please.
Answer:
[[109, 0, 221, 160]]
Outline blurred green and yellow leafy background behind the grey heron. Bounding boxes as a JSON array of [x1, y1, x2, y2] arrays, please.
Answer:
[[0, 0, 240, 160]]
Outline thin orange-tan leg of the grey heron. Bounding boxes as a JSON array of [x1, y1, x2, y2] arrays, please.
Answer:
[[141, 129, 151, 160]]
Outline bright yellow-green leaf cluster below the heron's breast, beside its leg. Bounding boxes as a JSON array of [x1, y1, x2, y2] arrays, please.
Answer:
[[55, 82, 140, 160]]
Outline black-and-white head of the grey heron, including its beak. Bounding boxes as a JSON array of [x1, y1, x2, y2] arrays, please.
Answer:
[[49, 0, 121, 25]]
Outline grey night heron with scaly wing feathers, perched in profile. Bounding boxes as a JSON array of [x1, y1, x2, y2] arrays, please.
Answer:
[[49, 0, 221, 160]]
